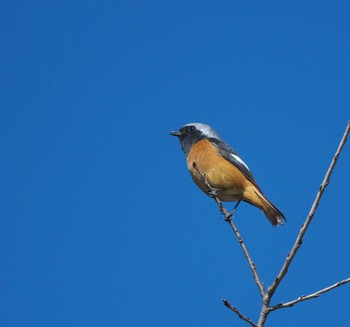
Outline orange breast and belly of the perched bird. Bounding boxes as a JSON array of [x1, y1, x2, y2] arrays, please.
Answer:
[[187, 140, 249, 201]]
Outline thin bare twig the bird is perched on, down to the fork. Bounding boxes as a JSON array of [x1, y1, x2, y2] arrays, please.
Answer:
[[193, 163, 265, 298]]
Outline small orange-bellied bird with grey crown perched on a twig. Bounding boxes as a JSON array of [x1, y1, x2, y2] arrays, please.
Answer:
[[169, 123, 286, 226]]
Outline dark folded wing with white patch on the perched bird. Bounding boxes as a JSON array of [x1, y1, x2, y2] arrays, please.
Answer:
[[210, 139, 260, 190]]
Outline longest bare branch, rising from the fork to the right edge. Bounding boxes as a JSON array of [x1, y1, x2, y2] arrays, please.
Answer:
[[267, 121, 350, 299]]
